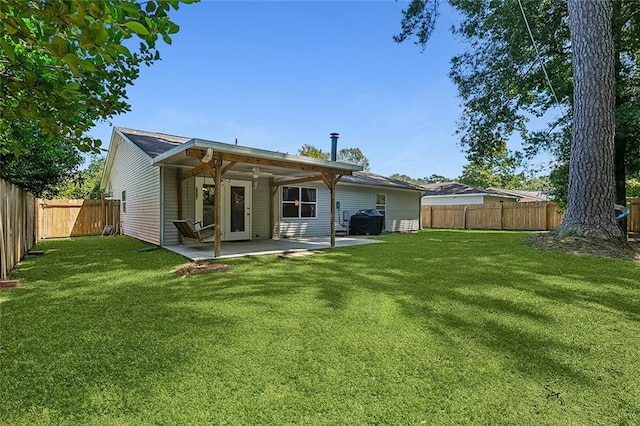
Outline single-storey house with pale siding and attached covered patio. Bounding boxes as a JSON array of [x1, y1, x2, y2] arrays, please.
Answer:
[[101, 127, 423, 256]]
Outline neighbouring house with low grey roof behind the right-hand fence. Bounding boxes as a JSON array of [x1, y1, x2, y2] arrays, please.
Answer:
[[422, 182, 519, 206]]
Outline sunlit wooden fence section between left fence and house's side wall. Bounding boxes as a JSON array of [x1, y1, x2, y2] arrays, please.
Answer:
[[38, 199, 120, 238]]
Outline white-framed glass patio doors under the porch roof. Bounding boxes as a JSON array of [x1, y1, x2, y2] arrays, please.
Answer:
[[195, 177, 252, 241]]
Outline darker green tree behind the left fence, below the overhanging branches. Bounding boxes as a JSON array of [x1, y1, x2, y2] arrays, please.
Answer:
[[0, 125, 82, 197]]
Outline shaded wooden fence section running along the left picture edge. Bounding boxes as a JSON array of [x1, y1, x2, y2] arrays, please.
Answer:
[[0, 179, 36, 280]]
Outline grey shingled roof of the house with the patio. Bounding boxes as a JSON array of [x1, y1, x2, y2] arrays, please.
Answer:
[[109, 127, 423, 191]]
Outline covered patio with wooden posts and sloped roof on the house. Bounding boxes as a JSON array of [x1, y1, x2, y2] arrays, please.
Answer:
[[152, 133, 362, 259]]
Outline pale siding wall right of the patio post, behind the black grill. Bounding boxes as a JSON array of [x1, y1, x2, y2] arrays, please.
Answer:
[[336, 185, 421, 232]]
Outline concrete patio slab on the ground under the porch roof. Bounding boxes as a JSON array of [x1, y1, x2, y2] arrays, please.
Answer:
[[164, 236, 382, 261]]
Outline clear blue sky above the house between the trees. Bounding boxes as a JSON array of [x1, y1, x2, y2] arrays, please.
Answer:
[[91, 0, 466, 178]]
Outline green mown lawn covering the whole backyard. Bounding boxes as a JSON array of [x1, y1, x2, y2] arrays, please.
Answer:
[[0, 231, 640, 425]]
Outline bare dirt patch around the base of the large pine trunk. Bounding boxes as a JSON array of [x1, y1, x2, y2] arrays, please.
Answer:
[[525, 232, 640, 262]]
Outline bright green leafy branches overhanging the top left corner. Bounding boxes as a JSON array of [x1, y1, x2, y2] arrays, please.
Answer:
[[0, 0, 194, 153]]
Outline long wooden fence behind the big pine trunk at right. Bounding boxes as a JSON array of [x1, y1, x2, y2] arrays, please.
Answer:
[[422, 198, 640, 232]]
